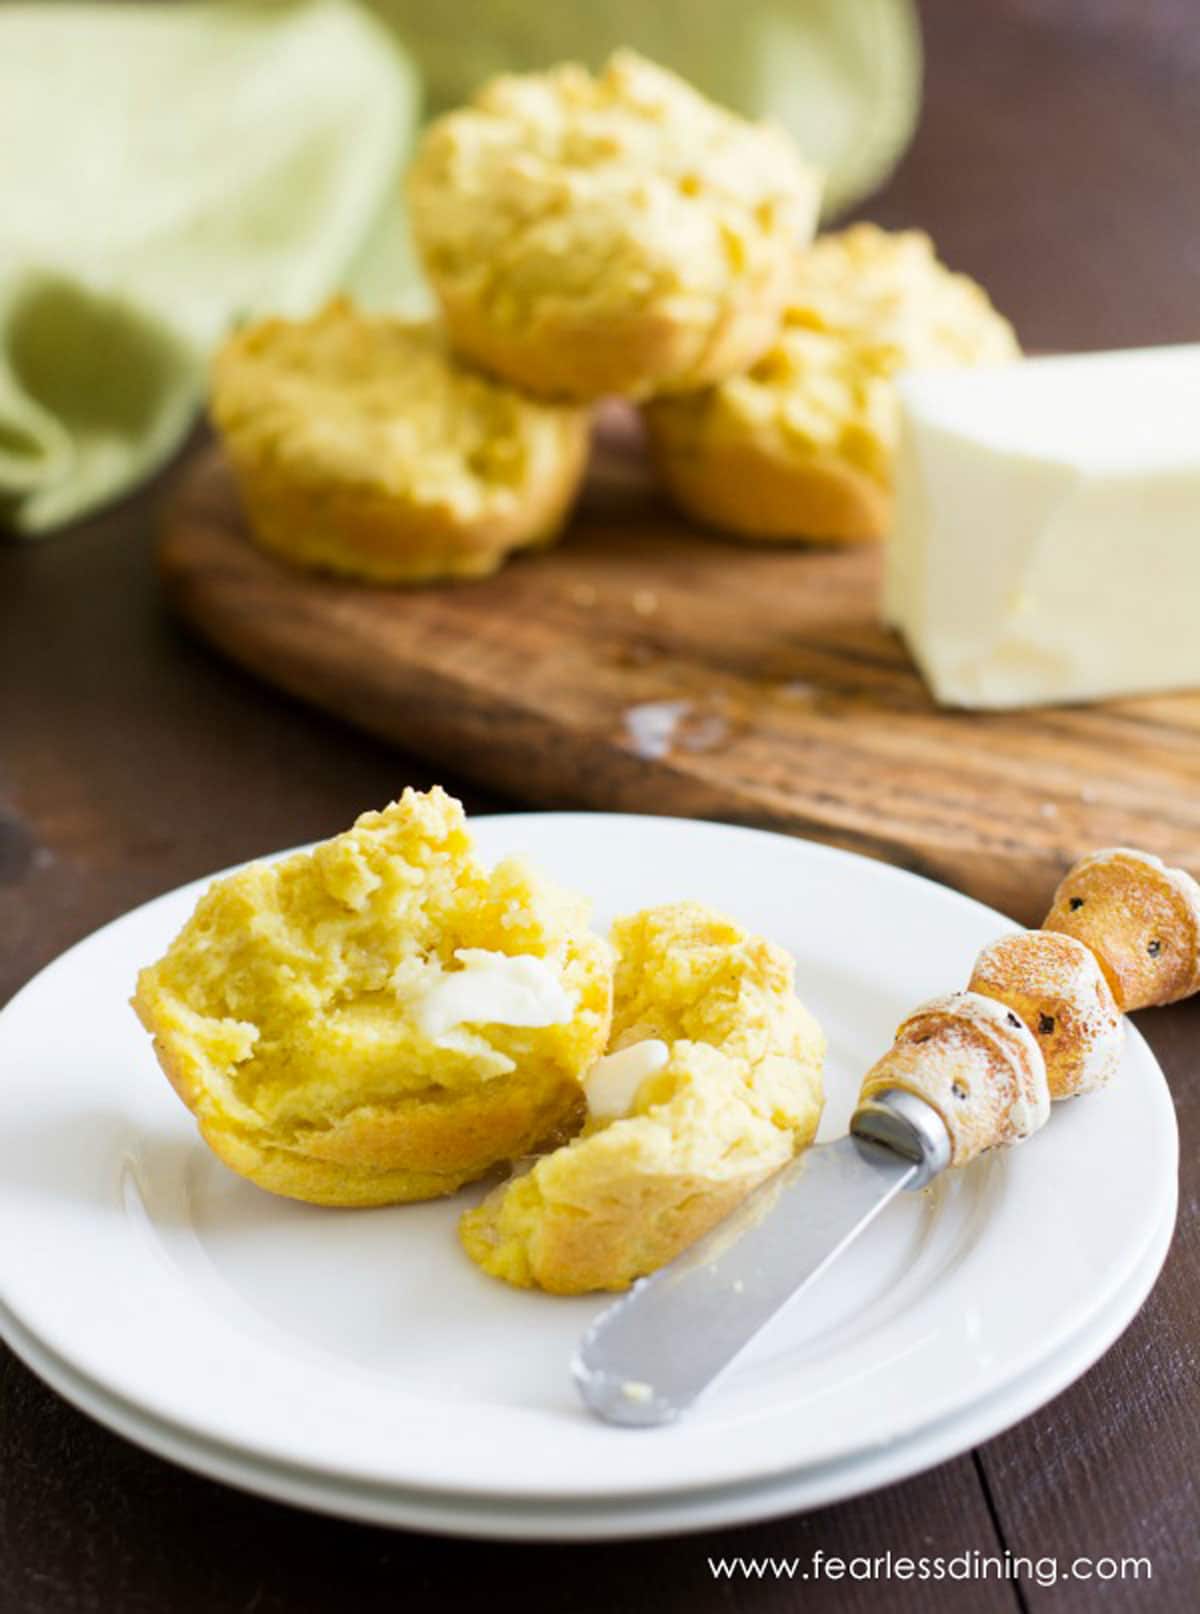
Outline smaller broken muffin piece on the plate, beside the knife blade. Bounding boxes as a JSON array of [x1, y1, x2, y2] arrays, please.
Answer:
[[460, 902, 825, 1294]]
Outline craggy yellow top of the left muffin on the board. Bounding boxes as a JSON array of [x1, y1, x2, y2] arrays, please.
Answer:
[[212, 299, 586, 516]]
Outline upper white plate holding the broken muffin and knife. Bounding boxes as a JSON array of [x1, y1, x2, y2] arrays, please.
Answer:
[[0, 815, 1177, 1506]]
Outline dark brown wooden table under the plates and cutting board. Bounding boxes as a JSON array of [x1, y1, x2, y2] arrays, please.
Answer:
[[0, 0, 1200, 1614]]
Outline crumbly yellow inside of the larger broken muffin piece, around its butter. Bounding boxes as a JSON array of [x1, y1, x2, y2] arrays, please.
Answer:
[[136, 791, 609, 1164]]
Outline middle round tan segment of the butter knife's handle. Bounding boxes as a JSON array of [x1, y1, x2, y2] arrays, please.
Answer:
[[967, 930, 1126, 1099]]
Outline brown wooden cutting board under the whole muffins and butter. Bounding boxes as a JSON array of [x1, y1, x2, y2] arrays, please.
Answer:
[[160, 413, 1200, 923]]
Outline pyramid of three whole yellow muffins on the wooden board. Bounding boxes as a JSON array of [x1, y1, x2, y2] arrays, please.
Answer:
[[212, 52, 1019, 583]]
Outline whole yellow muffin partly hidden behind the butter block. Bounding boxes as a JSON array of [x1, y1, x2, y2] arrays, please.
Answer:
[[644, 224, 1019, 542]]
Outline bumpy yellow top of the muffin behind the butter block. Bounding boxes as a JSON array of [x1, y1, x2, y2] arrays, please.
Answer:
[[652, 224, 1019, 483]]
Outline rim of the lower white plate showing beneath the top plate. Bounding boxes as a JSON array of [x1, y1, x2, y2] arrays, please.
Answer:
[[0, 1194, 1176, 1541]]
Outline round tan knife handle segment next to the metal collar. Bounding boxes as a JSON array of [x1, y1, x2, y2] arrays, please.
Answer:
[[861, 993, 1050, 1165]]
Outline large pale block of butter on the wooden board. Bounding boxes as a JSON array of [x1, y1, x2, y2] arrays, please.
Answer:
[[883, 345, 1200, 707]]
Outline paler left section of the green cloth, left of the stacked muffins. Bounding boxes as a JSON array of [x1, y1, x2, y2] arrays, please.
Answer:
[[0, 0, 417, 536]]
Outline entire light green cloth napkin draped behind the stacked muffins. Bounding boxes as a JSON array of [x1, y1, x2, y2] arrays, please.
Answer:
[[0, 0, 921, 537]]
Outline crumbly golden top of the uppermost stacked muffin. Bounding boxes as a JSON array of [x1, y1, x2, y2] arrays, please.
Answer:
[[409, 52, 819, 329]]
